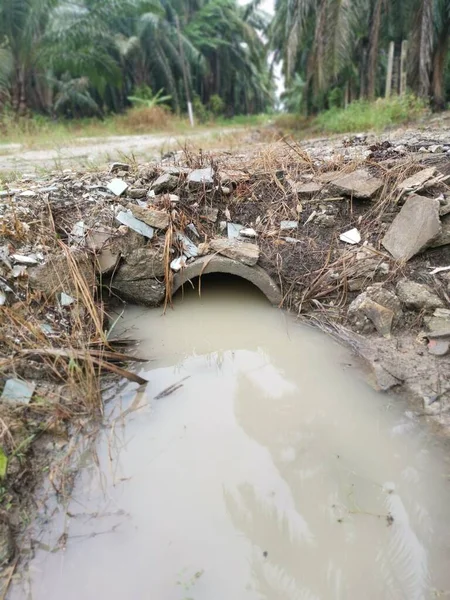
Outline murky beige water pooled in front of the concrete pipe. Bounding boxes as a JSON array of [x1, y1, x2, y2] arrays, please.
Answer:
[[11, 279, 450, 600]]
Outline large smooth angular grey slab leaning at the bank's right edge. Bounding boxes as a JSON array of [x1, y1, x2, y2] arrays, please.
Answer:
[[382, 195, 442, 261]]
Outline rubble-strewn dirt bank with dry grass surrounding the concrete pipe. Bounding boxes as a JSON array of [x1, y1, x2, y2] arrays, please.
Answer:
[[0, 123, 450, 584]]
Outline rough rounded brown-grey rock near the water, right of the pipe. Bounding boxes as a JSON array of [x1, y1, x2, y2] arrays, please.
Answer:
[[347, 284, 402, 336]]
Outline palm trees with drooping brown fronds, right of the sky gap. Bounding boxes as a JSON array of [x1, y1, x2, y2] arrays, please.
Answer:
[[271, 0, 450, 112]]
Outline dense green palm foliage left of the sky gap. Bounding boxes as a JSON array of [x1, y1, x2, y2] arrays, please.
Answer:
[[0, 0, 272, 117]]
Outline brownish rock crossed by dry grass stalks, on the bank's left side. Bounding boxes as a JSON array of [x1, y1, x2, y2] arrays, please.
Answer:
[[28, 252, 96, 298]]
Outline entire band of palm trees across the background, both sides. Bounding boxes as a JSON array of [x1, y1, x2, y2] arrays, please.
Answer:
[[0, 0, 450, 118]]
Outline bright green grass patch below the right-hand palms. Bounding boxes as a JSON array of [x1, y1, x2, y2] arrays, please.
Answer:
[[312, 95, 427, 133]]
